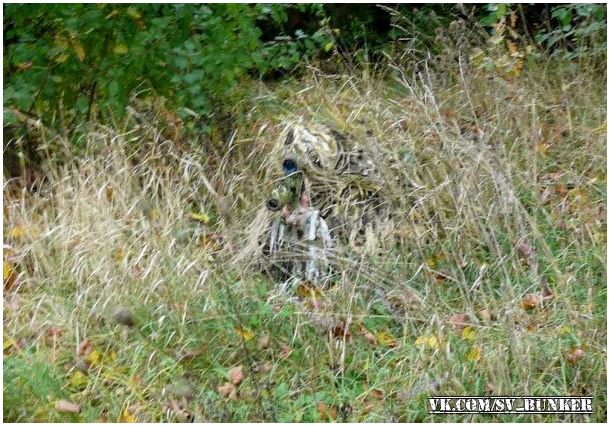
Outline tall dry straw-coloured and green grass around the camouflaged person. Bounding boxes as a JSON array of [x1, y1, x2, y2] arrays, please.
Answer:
[[3, 57, 607, 422]]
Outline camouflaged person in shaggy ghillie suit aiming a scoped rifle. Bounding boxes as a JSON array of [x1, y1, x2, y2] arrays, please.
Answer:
[[264, 123, 391, 292]]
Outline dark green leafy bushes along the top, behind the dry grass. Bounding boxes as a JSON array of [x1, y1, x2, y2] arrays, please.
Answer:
[[4, 4, 606, 136]]
